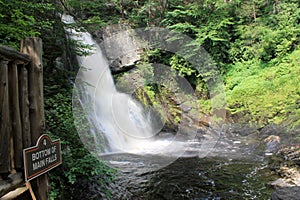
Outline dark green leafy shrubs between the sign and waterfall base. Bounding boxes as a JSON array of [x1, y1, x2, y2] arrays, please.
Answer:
[[45, 90, 114, 199]]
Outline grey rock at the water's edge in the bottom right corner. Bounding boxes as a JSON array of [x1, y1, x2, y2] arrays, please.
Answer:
[[271, 187, 300, 200]]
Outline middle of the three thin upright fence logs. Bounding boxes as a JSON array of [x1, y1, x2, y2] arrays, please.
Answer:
[[8, 61, 23, 169]]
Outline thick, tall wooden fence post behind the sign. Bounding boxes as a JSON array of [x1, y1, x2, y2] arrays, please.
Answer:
[[21, 38, 49, 200]]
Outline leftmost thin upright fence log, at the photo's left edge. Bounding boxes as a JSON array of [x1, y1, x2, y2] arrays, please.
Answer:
[[0, 60, 11, 173]]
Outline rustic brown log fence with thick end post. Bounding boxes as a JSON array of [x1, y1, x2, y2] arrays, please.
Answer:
[[0, 38, 47, 199]]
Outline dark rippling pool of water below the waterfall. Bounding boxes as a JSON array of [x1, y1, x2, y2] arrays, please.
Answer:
[[104, 130, 276, 200]]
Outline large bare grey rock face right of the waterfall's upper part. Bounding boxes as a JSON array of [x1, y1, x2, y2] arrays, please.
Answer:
[[93, 25, 142, 73]]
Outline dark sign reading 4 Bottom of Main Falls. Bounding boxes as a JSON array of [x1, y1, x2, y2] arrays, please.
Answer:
[[23, 134, 62, 181]]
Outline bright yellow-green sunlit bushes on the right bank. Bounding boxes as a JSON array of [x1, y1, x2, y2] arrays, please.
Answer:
[[226, 50, 300, 127]]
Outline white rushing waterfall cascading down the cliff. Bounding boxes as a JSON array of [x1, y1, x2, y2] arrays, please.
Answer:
[[62, 15, 153, 152]]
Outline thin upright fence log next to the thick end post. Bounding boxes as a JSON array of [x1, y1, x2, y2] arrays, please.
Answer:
[[19, 65, 31, 148]]
